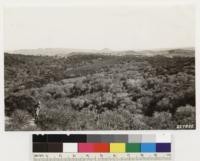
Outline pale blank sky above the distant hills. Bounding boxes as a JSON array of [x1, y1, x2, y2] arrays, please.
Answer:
[[4, 5, 195, 50]]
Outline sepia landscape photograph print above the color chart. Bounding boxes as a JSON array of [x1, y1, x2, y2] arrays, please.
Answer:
[[4, 4, 196, 131]]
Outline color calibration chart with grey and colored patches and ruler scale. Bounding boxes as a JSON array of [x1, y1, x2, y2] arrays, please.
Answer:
[[32, 134, 173, 161]]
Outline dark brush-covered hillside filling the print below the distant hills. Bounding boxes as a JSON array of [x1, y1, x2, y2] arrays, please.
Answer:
[[4, 53, 195, 130]]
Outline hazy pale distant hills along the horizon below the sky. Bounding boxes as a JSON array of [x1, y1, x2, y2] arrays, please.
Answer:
[[8, 48, 195, 57]]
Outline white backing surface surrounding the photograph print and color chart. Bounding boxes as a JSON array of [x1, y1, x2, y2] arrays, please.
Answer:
[[0, 0, 200, 161]]
